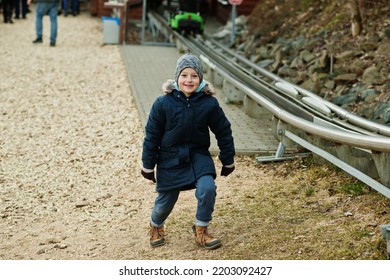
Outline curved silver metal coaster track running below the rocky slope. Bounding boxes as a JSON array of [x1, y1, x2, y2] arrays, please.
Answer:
[[146, 10, 390, 198]]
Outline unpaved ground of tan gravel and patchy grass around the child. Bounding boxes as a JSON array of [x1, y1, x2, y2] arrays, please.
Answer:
[[0, 5, 390, 260]]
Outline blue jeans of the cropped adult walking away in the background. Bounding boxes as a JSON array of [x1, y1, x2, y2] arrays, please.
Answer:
[[35, 2, 59, 43]]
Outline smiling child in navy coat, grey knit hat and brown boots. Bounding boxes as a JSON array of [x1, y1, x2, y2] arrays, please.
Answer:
[[141, 54, 235, 249]]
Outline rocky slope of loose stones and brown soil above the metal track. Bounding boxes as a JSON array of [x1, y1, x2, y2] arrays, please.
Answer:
[[213, 0, 390, 125]]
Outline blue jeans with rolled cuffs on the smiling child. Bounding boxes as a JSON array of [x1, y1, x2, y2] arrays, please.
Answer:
[[151, 175, 217, 227]]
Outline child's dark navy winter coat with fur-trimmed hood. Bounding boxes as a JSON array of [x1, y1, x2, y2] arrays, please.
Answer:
[[142, 80, 235, 192]]
